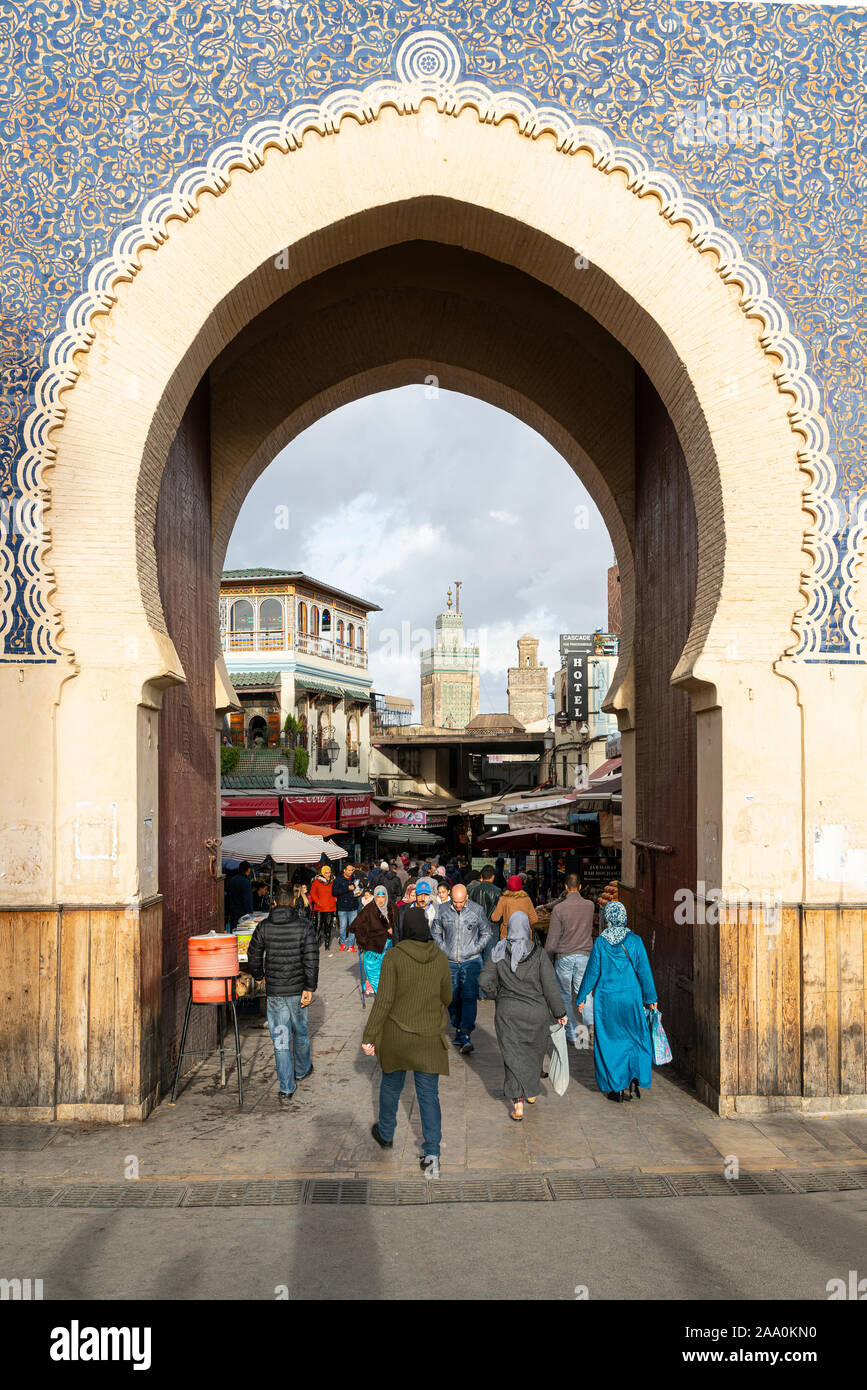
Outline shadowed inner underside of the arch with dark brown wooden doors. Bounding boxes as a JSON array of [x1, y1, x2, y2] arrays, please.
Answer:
[[156, 240, 697, 1083]]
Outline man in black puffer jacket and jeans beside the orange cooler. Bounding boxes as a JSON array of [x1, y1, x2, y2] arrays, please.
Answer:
[[247, 884, 320, 1102]]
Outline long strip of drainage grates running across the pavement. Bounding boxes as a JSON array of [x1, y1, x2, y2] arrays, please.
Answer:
[[0, 1166, 867, 1211]]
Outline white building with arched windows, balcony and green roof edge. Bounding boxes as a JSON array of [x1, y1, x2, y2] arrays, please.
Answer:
[[220, 570, 379, 783]]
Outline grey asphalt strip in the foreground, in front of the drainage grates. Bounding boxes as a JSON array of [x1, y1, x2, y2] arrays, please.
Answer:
[[0, 1193, 867, 1306]]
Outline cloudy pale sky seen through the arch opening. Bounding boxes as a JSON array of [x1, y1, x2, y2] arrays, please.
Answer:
[[226, 386, 614, 713]]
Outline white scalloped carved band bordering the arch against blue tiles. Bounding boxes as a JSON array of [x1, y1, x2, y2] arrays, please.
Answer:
[[15, 67, 867, 660]]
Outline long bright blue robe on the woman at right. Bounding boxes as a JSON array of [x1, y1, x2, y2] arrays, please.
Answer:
[[578, 931, 656, 1093]]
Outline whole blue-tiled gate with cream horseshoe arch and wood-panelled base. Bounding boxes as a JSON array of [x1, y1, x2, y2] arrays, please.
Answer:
[[0, 10, 867, 1122]]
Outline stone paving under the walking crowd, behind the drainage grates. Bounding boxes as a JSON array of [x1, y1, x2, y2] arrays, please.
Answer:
[[0, 951, 867, 1184]]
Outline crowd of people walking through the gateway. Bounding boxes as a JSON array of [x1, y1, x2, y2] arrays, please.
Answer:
[[237, 855, 657, 1179]]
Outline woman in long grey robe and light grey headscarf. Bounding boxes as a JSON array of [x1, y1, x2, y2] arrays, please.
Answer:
[[479, 912, 565, 1120]]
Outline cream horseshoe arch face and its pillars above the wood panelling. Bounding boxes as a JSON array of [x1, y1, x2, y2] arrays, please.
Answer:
[[3, 90, 863, 1111]]
